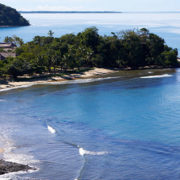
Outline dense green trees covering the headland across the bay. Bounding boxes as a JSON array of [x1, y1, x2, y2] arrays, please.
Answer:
[[0, 27, 178, 77]]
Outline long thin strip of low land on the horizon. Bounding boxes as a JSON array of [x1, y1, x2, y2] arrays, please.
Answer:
[[20, 11, 121, 13]]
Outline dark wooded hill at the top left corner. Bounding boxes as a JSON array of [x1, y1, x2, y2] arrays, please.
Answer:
[[0, 4, 29, 26]]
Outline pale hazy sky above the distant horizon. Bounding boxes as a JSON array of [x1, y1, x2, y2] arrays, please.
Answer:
[[0, 0, 180, 11]]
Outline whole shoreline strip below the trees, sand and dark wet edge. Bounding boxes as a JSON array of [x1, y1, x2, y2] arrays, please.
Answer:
[[0, 66, 179, 93]]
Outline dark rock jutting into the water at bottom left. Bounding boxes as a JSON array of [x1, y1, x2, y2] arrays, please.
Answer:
[[0, 160, 35, 175]]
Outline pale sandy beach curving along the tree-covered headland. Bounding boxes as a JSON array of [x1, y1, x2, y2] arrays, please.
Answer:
[[0, 68, 116, 92]]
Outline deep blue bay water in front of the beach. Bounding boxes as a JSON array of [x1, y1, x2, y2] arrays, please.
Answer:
[[0, 69, 180, 180]]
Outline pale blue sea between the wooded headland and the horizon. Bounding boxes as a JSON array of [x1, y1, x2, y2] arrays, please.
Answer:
[[0, 12, 180, 50]]
